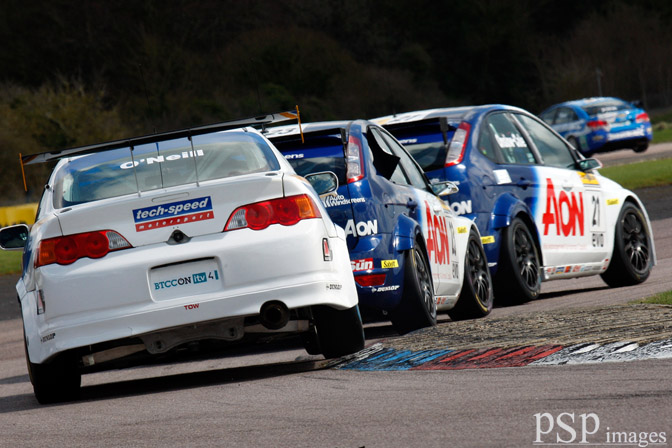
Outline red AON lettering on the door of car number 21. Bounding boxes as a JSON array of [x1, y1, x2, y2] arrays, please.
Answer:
[[541, 178, 584, 236]]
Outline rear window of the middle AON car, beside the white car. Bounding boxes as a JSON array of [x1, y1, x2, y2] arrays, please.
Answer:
[[273, 135, 347, 185]]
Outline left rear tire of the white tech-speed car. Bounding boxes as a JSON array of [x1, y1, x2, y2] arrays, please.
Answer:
[[23, 331, 82, 404]]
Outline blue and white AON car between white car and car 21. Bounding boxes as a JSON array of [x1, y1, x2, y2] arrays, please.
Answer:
[[266, 120, 493, 333]]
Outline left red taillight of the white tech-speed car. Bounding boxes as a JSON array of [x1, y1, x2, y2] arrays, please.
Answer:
[[35, 230, 132, 268]]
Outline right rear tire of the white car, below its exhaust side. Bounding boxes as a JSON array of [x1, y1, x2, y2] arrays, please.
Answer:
[[314, 305, 364, 359]]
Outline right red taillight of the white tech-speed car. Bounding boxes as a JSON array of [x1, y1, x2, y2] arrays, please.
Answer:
[[224, 194, 321, 231]]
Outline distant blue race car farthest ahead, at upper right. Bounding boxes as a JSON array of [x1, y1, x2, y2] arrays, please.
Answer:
[[539, 97, 653, 155]]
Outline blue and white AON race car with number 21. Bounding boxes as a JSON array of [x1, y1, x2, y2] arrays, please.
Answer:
[[373, 105, 655, 303]]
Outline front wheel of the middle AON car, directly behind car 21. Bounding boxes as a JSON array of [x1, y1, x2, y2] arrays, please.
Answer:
[[448, 229, 494, 320]]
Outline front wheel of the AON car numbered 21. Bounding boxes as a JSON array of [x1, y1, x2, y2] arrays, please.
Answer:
[[600, 202, 653, 287]]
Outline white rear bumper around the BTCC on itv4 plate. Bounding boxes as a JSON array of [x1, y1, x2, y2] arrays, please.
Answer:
[[22, 219, 358, 363]]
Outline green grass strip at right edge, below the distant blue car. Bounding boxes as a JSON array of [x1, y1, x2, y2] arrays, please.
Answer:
[[600, 159, 672, 190]]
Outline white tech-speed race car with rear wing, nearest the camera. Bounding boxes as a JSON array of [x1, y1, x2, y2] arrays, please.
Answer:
[[0, 114, 364, 403]]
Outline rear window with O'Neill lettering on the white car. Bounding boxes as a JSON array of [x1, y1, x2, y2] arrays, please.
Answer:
[[53, 132, 280, 208]]
